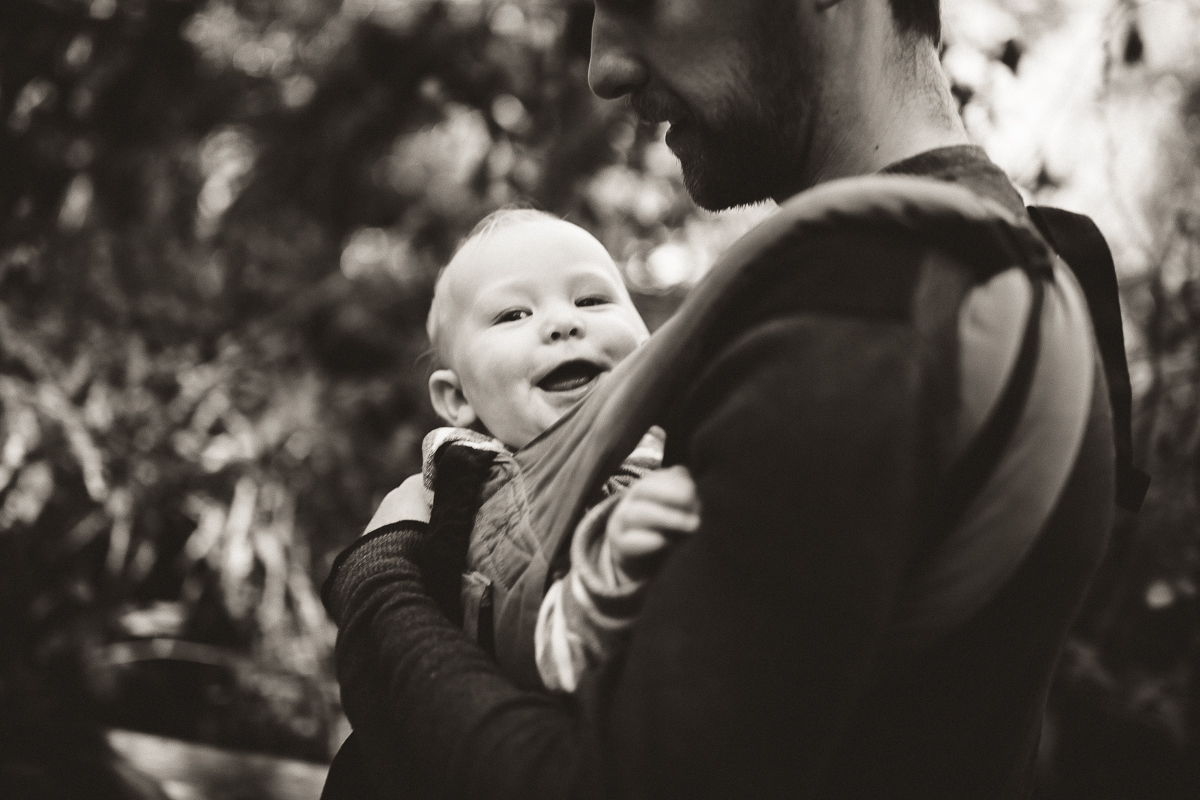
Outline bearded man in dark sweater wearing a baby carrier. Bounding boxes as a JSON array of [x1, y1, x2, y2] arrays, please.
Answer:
[[328, 0, 1114, 798]]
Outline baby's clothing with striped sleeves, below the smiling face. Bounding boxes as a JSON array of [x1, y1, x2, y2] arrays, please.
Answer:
[[421, 427, 664, 692]]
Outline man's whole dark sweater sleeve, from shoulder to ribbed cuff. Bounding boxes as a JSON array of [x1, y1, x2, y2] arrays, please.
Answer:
[[330, 315, 930, 798]]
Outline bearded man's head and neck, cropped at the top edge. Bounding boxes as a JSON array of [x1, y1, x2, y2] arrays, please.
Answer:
[[588, 0, 970, 209]]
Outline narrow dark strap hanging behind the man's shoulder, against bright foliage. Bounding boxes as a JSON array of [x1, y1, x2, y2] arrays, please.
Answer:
[[1028, 206, 1150, 513]]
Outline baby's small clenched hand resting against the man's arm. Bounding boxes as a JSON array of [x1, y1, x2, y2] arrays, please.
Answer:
[[605, 465, 700, 581]]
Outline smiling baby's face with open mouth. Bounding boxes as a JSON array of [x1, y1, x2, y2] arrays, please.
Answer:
[[445, 219, 649, 447]]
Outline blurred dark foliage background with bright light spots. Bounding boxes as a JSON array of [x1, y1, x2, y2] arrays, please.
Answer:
[[0, 0, 1200, 800]]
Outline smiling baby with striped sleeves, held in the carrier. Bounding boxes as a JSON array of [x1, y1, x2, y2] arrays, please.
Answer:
[[367, 210, 700, 692]]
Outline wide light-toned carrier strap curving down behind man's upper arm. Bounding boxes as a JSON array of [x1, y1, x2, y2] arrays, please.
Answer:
[[888, 225, 1112, 652]]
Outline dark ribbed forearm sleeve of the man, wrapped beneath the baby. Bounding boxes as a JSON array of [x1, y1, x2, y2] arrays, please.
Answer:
[[325, 523, 588, 799]]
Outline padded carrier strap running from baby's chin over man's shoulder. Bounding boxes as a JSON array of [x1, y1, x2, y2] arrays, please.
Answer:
[[515, 175, 1060, 592]]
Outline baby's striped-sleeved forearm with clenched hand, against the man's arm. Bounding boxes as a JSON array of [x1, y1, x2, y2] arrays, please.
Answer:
[[534, 467, 700, 692]]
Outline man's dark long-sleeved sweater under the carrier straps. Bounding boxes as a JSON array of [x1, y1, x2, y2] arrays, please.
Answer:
[[328, 149, 1112, 798]]
